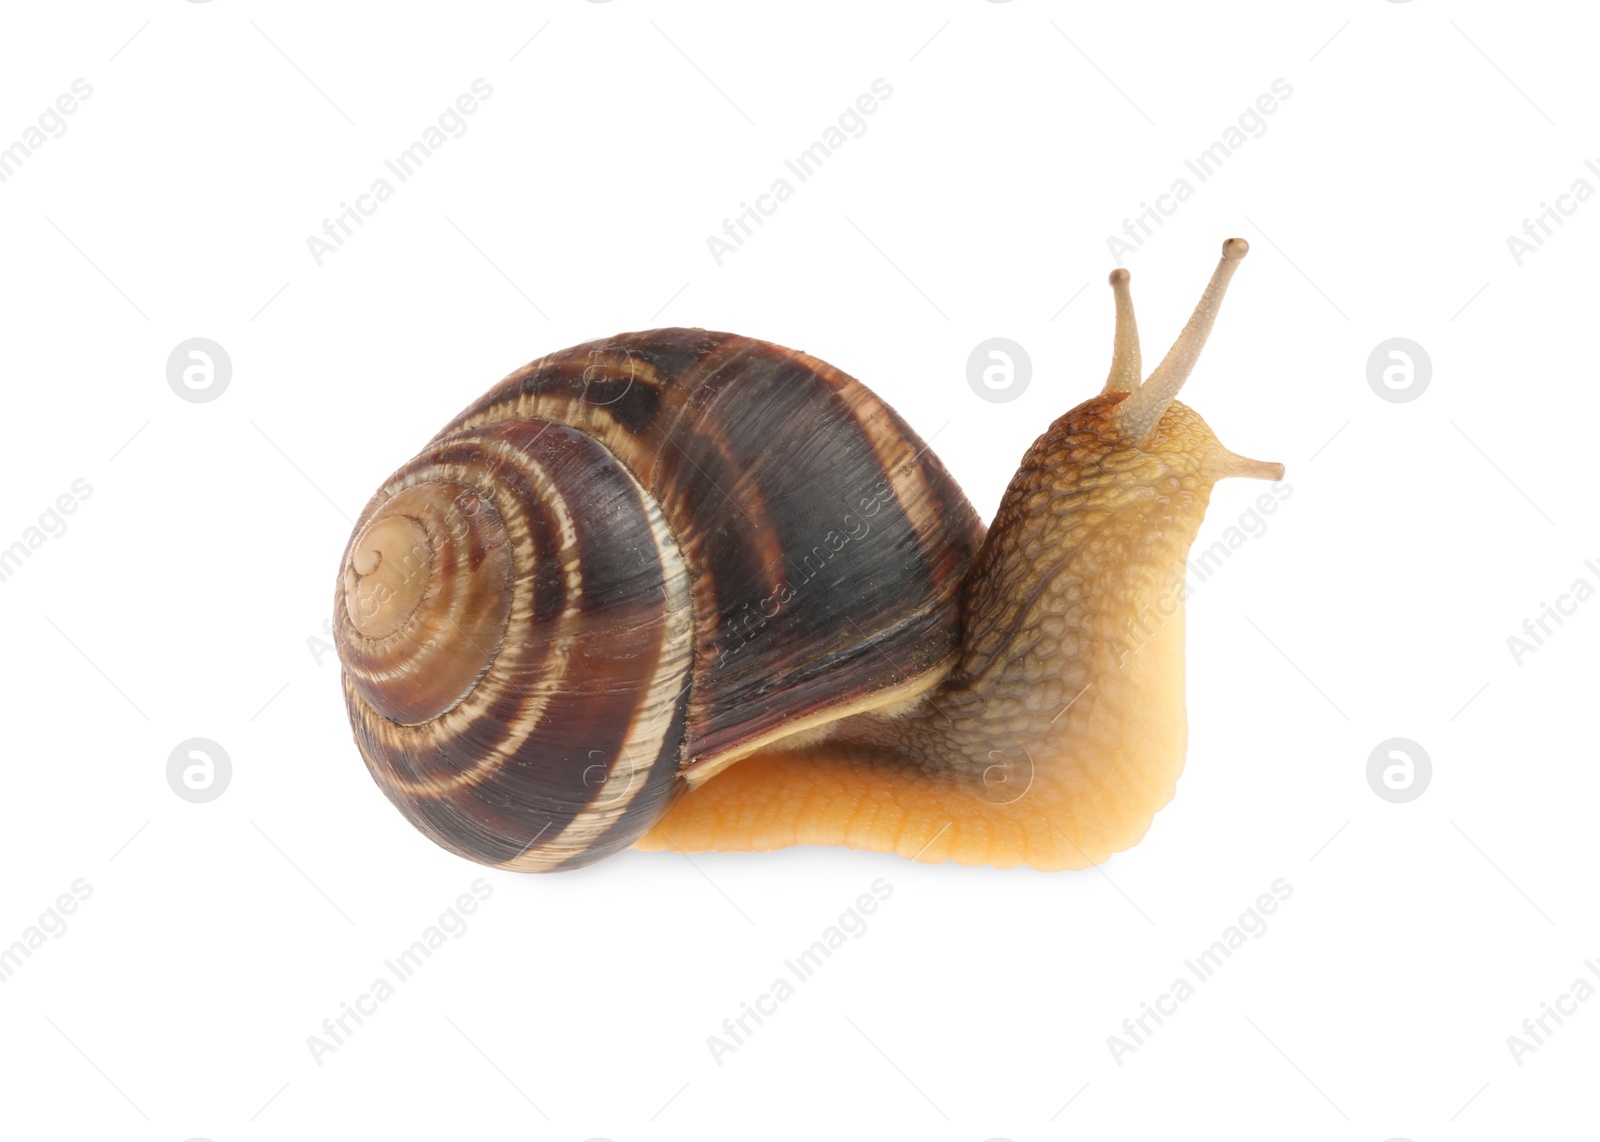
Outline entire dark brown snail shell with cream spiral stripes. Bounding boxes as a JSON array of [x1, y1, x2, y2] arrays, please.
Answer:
[[334, 329, 984, 870]]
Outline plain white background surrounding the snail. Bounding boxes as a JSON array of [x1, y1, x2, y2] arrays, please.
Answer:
[[0, 0, 1600, 1142]]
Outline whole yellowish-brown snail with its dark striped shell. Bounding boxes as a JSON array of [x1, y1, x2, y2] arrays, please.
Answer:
[[334, 238, 1283, 872]]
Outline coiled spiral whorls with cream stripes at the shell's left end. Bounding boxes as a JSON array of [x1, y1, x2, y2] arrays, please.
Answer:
[[334, 419, 691, 868]]
